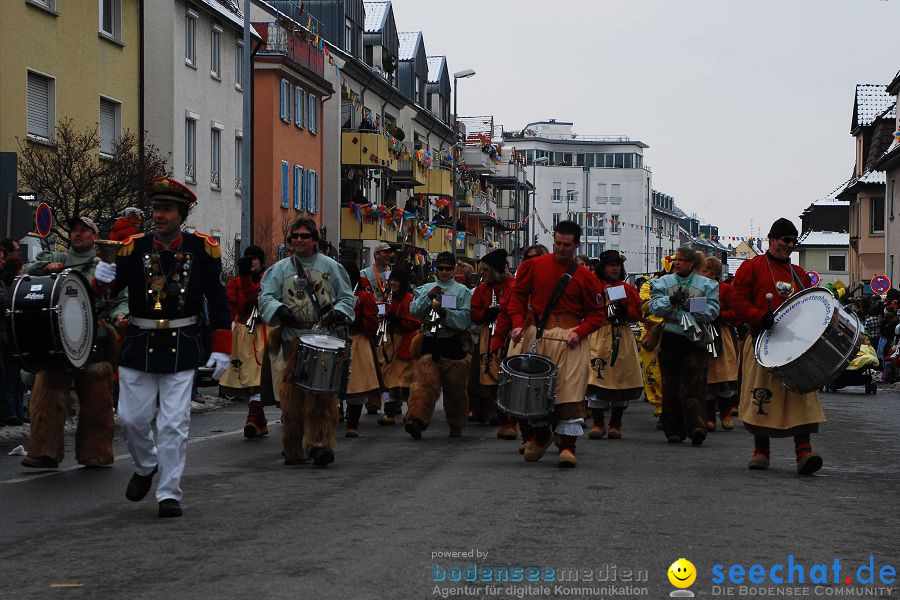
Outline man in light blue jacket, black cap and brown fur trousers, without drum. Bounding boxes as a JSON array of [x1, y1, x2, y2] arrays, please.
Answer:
[[404, 252, 472, 440]]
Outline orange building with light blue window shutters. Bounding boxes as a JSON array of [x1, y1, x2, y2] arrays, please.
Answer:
[[253, 22, 334, 255]]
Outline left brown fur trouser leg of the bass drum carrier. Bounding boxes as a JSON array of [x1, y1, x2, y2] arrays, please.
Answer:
[[28, 371, 72, 462]]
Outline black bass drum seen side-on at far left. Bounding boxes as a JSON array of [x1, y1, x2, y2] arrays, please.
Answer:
[[6, 269, 97, 373]]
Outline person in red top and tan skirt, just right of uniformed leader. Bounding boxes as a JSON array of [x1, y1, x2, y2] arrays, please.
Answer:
[[219, 246, 269, 439]]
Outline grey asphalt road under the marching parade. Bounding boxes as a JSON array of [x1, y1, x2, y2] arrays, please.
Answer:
[[0, 388, 900, 599]]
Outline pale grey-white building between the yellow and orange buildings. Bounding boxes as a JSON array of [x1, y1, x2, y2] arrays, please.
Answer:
[[143, 0, 245, 255]]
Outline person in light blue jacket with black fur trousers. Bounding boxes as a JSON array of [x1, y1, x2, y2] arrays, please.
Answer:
[[649, 247, 719, 446]]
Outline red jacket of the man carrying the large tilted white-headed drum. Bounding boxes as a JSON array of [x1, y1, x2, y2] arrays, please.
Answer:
[[732, 252, 812, 326]]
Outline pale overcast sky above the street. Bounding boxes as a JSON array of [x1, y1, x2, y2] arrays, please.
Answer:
[[393, 0, 900, 236]]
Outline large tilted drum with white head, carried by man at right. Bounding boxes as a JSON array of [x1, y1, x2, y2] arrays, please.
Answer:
[[755, 287, 865, 394]]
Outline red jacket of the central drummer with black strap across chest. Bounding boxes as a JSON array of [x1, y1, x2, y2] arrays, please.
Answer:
[[509, 254, 607, 339]]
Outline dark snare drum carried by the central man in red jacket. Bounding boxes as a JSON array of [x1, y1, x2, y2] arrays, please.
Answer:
[[497, 354, 556, 419]]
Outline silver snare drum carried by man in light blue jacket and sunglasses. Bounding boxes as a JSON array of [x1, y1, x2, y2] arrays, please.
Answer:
[[293, 331, 349, 394]]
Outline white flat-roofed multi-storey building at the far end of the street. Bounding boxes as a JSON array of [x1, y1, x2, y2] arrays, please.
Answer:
[[504, 119, 656, 271]]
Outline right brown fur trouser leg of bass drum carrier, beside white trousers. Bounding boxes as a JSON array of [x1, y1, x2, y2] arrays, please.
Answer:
[[75, 362, 115, 465]]
